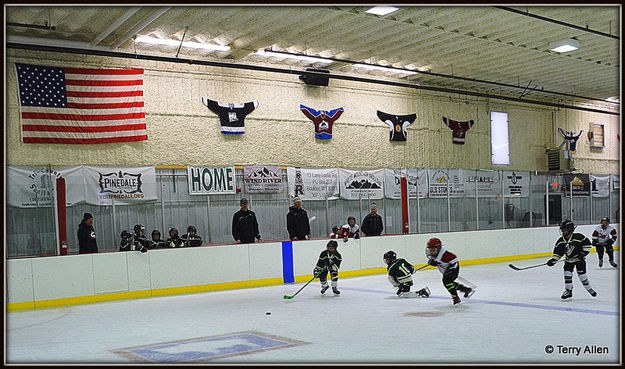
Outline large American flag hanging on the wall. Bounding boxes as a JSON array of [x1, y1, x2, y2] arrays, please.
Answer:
[[15, 63, 148, 144]]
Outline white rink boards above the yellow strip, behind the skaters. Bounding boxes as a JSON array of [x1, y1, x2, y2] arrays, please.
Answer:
[[6, 224, 620, 304]]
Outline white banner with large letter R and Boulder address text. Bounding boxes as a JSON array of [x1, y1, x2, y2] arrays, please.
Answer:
[[286, 167, 339, 200]]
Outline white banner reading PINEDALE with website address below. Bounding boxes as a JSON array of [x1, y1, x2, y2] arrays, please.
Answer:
[[83, 165, 158, 206]]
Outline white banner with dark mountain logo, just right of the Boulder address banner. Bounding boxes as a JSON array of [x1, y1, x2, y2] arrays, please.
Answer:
[[339, 168, 384, 200]]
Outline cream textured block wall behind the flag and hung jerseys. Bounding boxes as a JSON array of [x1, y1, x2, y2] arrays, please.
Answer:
[[5, 49, 620, 174]]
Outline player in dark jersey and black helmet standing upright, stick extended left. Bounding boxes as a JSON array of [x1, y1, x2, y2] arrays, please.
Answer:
[[547, 219, 597, 300]]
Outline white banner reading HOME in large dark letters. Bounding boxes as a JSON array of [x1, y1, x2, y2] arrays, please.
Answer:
[[187, 166, 237, 195]]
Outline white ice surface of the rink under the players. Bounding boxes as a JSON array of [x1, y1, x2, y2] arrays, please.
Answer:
[[5, 252, 621, 365]]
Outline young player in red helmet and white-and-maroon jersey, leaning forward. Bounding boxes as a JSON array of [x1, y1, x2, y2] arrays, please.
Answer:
[[425, 237, 475, 305]]
